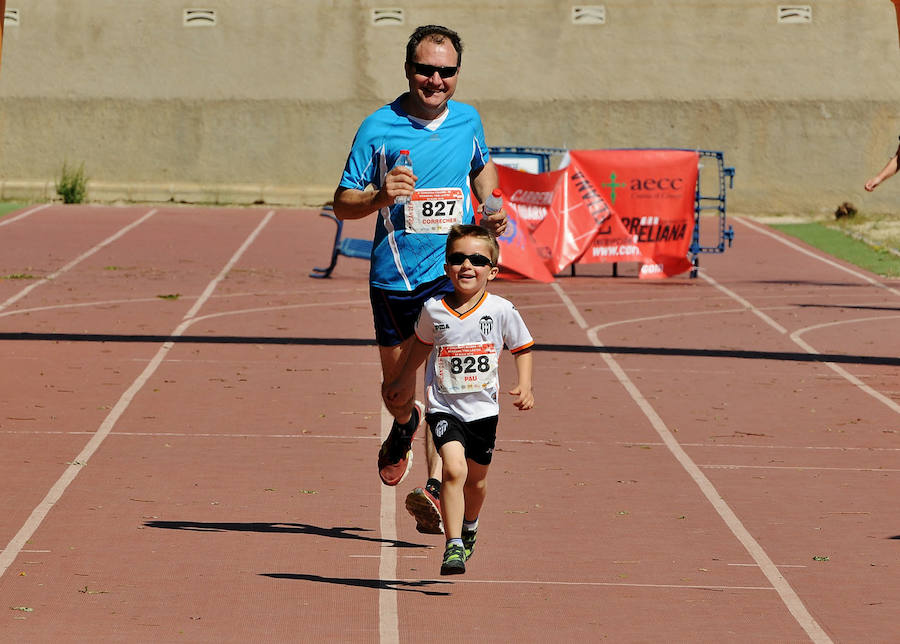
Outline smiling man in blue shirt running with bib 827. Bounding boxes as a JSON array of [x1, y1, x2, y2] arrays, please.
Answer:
[[334, 25, 506, 533]]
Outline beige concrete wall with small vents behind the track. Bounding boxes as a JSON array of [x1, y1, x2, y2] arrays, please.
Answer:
[[0, 0, 900, 212]]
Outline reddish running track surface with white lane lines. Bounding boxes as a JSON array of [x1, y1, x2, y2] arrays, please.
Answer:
[[0, 206, 900, 642]]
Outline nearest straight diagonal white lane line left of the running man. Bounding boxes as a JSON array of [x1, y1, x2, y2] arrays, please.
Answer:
[[0, 210, 275, 577]]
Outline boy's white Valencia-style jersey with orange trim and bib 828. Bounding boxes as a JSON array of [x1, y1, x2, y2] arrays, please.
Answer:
[[416, 293, 534, 421]]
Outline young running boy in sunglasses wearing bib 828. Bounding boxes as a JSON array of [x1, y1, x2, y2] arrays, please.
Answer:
[[387, 224, 534, 575]]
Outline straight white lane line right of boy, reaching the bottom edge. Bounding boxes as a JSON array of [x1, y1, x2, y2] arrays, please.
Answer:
[[550, 282, 831, 644]]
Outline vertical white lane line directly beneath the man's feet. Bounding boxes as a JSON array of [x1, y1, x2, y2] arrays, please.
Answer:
[[378, 406, 400, 644]]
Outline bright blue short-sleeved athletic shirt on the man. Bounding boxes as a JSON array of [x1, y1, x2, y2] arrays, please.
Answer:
[[340, 94, 490, 291]]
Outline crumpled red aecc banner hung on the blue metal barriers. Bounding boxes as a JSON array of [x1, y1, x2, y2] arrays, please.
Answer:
[[488, 150, 699, 279]]
